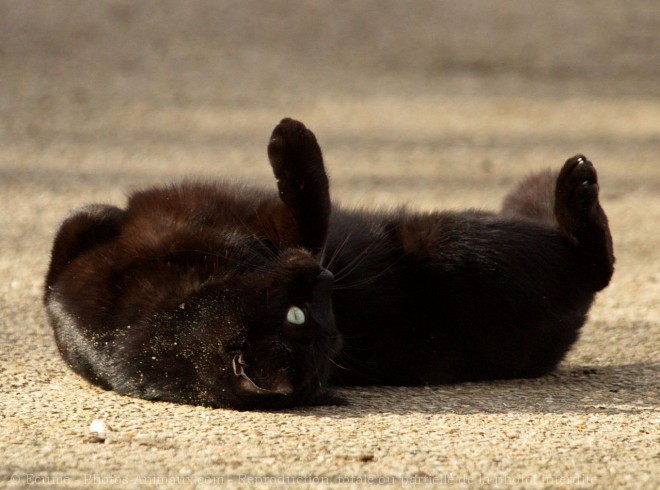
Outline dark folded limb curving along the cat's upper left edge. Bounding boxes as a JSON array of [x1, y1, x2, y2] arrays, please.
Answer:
[[45, 204, 124, 299]]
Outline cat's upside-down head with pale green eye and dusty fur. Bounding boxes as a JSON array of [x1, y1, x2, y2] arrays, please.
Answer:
[[174, 245, 341, 409]]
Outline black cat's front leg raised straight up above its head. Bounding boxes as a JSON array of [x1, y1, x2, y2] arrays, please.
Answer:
[[268, 118, 330, 253]]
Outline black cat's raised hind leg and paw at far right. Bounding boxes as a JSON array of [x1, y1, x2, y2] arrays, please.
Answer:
[[554, 155, 614, 291]]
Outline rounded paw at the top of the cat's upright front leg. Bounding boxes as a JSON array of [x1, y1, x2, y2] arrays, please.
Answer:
[[268, 118, 323, 181]]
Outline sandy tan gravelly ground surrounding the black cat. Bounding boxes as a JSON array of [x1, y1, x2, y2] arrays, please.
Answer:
[[0, 0, 660, 489]]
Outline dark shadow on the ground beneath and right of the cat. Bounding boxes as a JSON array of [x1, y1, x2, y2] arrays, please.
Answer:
[[287, 362, 660, 418]]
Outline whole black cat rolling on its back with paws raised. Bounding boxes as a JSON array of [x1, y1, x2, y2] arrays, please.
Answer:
[[45, 119, 614, 409]]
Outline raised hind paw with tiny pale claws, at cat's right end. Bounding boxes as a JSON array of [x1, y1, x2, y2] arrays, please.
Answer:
[[556, 155, 598, 221]]
